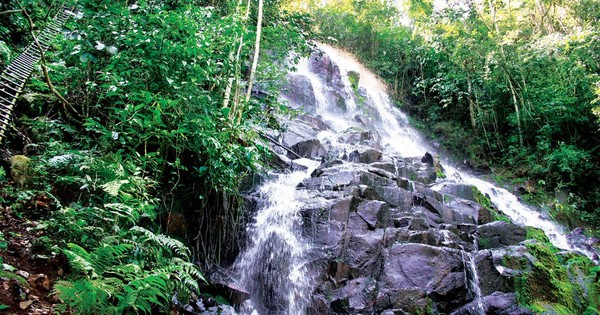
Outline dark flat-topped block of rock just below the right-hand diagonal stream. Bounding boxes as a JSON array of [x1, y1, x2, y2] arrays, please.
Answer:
[[477, 221, 527, 249]]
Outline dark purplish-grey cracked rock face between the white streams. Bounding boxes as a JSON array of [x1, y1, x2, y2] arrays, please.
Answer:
[[232, 48, 552, 315]]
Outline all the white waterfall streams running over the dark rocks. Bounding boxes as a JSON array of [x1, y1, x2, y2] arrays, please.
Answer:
[[234, 44, 587, 315]]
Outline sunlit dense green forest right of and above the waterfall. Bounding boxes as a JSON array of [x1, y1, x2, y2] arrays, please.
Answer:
[[293, 0, 600, 226]]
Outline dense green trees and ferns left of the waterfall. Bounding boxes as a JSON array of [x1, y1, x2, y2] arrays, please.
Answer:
[[0, 0, 307, 314]]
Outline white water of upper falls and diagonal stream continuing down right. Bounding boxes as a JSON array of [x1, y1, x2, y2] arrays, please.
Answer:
[[298, 44, 592, 256]]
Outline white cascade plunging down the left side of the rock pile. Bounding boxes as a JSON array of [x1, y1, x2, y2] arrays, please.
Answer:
[[234, 161, 318, 314]]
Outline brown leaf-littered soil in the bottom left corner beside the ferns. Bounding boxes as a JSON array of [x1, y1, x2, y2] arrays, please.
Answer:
[[0, 207, 68, 314]]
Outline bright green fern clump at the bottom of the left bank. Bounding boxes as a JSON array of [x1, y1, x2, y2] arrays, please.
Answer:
[[53, 230, 206, 314]]
